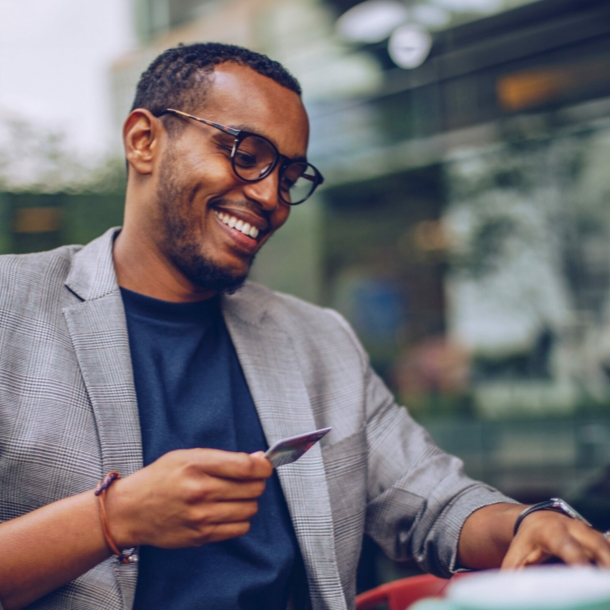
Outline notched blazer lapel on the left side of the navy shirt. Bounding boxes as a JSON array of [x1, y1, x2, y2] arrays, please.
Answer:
[[64, 231, 142, 609]]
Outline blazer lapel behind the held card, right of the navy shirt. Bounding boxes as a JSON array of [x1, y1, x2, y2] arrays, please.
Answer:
[[223, 287, 347, 610]]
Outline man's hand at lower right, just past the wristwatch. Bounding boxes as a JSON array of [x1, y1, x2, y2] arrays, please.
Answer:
[[502, 512, 610, 569]]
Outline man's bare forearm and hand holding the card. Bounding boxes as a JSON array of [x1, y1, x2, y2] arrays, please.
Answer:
[[0, 449, 273, 610]]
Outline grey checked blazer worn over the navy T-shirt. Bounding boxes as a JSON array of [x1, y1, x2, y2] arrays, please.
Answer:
[[0, 229, 507, 610]]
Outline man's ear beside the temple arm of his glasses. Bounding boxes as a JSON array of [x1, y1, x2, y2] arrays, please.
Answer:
[[123, 108, 165, 175]]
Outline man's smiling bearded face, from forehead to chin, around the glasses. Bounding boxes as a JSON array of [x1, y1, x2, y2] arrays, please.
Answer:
[[148, 63, 308, 292]]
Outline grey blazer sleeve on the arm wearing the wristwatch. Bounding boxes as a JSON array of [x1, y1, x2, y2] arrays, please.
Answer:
[[326, 308, 515, 577]]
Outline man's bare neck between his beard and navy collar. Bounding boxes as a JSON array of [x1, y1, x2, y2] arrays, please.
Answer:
[[112, 227, 216, 303]]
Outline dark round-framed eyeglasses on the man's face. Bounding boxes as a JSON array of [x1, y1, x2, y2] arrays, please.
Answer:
[[157, 108, 324, 205]]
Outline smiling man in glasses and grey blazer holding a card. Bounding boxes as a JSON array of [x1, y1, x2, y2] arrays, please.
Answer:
[[0, 44, 610, 610]]
